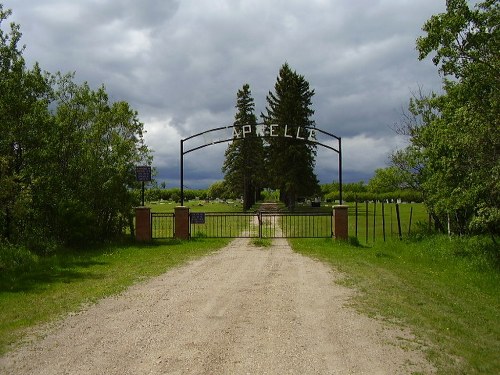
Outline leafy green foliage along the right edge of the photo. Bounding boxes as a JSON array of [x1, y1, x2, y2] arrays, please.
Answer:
[[393, 0, 500, 236]]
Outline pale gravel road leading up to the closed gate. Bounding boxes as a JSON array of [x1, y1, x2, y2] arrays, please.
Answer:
[[0, 239, 434, 375]]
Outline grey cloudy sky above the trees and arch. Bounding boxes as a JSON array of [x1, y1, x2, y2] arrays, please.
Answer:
[[0, 0, 445, 188]]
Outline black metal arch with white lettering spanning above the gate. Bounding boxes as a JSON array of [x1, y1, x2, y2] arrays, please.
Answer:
[[180, 123, 342, 206]]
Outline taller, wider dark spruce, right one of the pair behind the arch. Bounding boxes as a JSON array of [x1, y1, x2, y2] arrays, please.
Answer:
[[261, 64, 320, 207]]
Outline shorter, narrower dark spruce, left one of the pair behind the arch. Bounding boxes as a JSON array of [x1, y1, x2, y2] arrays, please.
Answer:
[[222, 84, 264, 210]]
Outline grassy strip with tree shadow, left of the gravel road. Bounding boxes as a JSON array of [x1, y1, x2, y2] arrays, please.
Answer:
[[0, 239, 229, 354]]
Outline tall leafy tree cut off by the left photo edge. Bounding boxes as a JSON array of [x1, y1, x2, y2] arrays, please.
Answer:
[[0, 4, 50, 247]]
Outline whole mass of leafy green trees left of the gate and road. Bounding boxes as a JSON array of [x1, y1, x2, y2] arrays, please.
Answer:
[[0, 4, 151, 252]]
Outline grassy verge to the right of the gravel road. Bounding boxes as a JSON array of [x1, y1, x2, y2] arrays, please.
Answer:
[[290, 236, 500, 374]]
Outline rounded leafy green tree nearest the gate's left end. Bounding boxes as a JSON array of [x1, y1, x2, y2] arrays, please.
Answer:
[[39, 75, 150, 247]]
